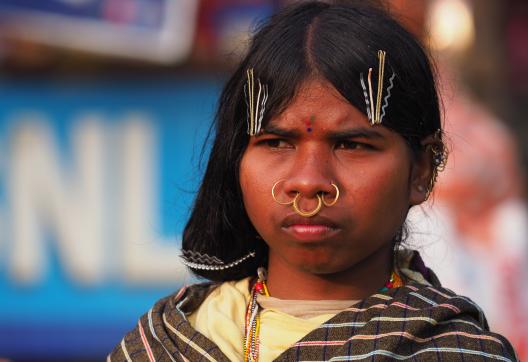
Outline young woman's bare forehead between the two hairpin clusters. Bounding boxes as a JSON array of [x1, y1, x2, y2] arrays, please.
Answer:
[[269, 79, 370, 128]]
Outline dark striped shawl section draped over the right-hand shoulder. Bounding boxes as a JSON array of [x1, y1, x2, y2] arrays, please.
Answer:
[[279, 281, 518, 362]]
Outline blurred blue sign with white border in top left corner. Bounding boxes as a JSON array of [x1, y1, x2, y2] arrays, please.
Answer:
[[0, 0, 199, 62]]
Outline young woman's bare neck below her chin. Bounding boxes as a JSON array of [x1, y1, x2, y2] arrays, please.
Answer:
[[267, 245, 393, 300]]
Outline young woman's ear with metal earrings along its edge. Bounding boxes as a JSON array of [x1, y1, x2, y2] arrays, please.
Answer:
[[409, 135, 441, 206]]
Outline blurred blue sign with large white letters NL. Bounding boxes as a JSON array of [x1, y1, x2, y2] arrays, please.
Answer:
[[0, 79, 222, 360]]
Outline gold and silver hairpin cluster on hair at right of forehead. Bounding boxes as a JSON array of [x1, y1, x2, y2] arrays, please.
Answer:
[[359, 50, 396, 125]]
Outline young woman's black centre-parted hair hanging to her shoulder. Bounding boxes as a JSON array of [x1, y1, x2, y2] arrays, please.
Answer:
[[182, 0, 441, 281]]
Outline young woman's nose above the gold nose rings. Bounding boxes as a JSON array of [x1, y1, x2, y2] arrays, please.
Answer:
[[283, 152, 335, 203]]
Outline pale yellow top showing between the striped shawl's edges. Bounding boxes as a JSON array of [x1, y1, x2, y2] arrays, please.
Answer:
[[188, 278, 354, 361]]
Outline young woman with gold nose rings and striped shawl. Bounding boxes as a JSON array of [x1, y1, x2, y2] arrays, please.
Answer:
[[109, 1, 516, 361]]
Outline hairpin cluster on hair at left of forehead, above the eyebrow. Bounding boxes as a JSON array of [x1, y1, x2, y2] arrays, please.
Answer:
[[244, 68, 268, 136]]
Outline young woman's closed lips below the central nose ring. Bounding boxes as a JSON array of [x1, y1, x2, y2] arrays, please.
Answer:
[[281, 214, 340, 241]]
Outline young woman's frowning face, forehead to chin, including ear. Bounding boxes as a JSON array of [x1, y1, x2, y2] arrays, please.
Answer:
[[240, 80, 426, 274]]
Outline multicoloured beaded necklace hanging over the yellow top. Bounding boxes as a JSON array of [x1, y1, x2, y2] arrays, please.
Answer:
[[244, 268, 403, 362]]
